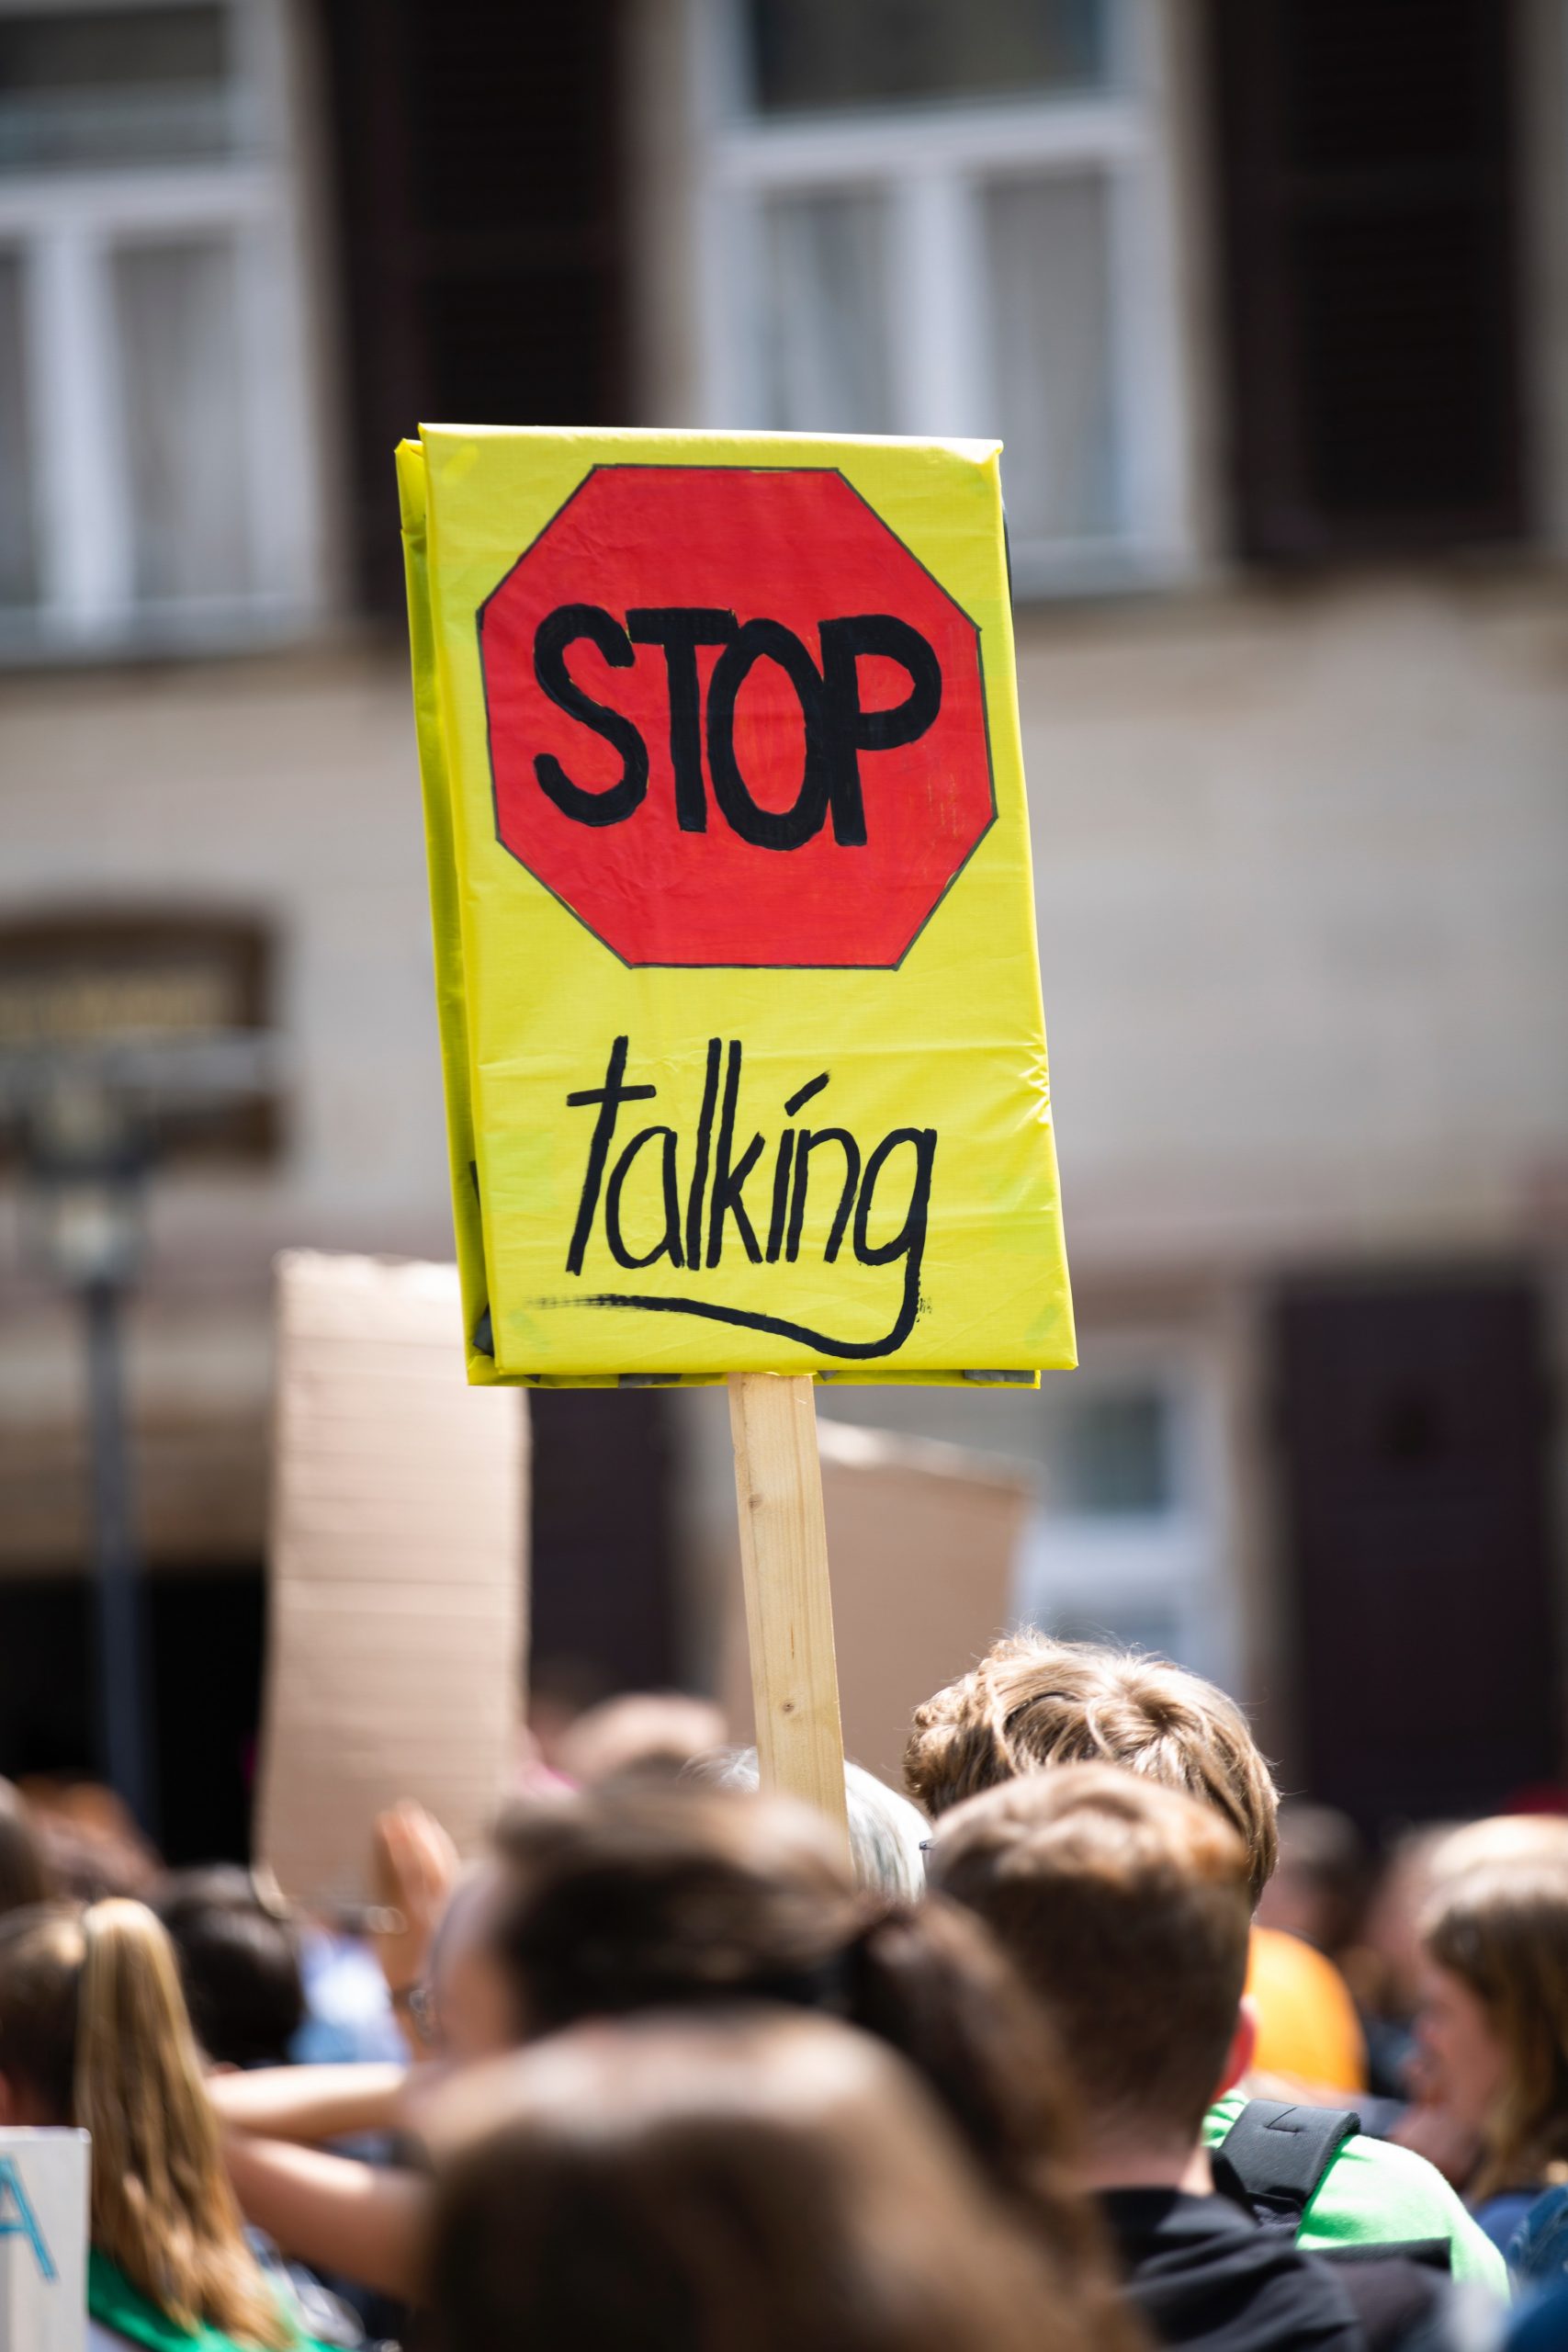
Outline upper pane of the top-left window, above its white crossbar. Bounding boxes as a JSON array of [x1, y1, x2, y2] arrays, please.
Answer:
[[0, 5, 232, 172]]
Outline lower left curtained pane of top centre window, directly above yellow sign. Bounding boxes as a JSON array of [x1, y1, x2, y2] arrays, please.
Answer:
[[761, 195, 891, 433]]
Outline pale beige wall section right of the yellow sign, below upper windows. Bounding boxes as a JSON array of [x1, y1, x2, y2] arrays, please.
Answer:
[[1021, 576, 1568, 1272]]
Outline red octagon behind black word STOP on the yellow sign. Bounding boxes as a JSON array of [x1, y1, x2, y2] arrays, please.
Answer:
[[479, 466, 995, 969]]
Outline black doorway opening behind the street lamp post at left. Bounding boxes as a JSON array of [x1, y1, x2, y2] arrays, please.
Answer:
[[0, 1569, 265, 1863]]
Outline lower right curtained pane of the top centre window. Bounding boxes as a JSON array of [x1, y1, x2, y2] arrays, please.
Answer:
[[983, 172, 1117, 543]]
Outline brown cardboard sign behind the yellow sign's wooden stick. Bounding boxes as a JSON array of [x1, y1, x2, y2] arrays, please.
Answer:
[[724, 1420, 1034, 1788]]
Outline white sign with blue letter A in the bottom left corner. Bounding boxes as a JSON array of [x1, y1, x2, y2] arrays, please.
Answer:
[[0, 2129, 89, 2352]]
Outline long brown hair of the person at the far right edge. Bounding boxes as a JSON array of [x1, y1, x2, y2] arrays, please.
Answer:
[[1422, 1856, 1568, 2201]]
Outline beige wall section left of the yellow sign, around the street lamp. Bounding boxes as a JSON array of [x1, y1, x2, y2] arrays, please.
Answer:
[[0, 651, 451, 1566]]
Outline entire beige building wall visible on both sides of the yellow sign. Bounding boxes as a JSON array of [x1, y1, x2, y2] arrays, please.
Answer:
[[0, 571, 1568, 1731]]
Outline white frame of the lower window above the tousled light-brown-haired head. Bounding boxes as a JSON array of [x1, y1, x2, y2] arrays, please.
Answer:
[[1016, 1331, 1241, 1689]]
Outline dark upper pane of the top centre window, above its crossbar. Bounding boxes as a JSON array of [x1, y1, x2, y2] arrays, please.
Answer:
[[750, 0, 1110, 115]]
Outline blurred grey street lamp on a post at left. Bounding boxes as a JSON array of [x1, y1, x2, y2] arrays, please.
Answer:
[[0, 1030, 277, 1835]]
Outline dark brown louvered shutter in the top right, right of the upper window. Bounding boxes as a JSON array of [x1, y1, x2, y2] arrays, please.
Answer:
[[1211, 0, 1526, 562]]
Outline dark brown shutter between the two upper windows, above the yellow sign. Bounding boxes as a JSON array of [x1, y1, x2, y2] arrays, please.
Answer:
[[317, 0, 626, 612]]
